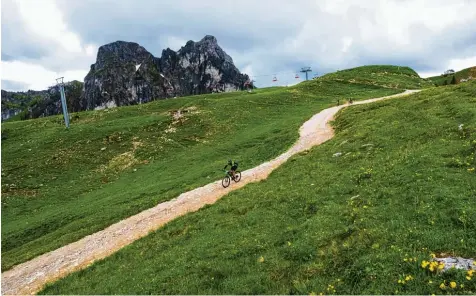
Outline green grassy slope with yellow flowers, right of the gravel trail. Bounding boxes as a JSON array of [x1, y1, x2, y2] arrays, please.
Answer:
[[42, 82, 476, 294]]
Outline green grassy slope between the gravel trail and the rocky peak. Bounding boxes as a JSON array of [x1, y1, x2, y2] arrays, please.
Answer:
[[2, 81, 400, 270]]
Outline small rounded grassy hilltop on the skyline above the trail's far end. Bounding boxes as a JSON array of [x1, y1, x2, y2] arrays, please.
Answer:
[[318, 65, 433, 89]]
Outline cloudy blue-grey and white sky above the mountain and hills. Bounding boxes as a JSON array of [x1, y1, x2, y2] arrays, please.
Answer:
[[1, 0, 476, 90]]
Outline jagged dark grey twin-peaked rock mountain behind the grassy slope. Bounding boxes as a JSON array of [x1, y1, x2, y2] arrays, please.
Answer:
[[79, 35, 249, 110]]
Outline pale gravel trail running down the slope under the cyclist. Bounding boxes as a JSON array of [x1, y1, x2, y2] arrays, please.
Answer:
[[2, 90, 418, 295]]
